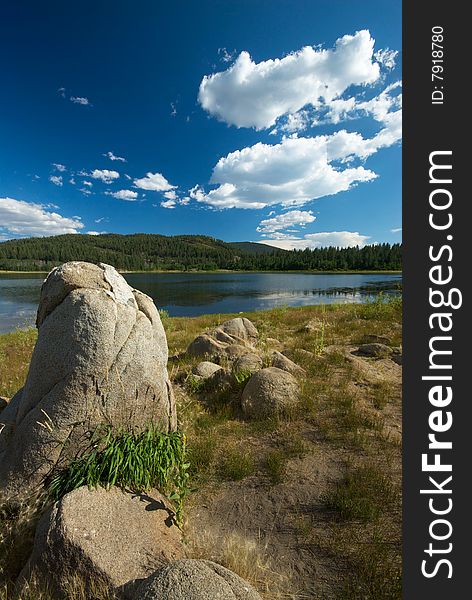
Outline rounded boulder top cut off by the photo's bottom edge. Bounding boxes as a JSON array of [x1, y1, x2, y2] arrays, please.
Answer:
[[133, 559, 262, 600]]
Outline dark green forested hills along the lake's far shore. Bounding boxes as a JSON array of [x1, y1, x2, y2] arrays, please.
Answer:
[[0, 233, 401, 271]]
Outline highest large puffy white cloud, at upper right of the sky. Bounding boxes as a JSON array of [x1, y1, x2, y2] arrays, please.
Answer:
[[198, 30, 380, 130]]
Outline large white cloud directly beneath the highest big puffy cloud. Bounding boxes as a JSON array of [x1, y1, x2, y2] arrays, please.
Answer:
[[189, 130, 380, 209]]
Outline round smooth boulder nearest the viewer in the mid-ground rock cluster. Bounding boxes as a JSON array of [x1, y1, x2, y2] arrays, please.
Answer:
[[241, 367, 300, 418]]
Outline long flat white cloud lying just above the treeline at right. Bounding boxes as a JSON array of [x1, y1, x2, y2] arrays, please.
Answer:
[[262, 231, 370, 250]]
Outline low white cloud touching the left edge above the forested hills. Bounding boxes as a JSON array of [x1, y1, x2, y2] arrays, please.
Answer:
[[0, 198, 84, 236]]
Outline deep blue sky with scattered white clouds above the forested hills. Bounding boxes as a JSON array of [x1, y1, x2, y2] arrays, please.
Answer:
[[0, 0, 401, 248]]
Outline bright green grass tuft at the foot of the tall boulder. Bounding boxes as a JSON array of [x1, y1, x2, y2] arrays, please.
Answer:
[[48, 424, 190, 526]]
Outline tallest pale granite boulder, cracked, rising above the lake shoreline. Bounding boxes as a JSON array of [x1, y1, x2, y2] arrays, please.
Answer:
[[0, 262, 176, 498]]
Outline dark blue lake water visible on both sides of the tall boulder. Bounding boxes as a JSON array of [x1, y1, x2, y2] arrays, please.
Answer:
[[0, 273, 402, 333]]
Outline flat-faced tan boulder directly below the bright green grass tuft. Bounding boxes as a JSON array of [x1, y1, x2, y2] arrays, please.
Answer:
[[17, 486, 184, 591]]
